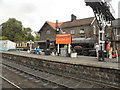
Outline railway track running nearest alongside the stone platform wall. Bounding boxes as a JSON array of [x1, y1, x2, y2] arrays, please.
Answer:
[[2, 60, 117, 89]]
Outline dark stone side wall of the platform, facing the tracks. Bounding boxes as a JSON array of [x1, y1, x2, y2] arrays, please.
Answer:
[[2, 53, 120, 87]]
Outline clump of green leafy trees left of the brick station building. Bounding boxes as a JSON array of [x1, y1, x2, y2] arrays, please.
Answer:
[[1, 18, 34, 42]]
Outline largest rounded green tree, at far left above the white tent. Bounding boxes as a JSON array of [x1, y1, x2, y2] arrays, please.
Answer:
[[2, 18, 25, 41]]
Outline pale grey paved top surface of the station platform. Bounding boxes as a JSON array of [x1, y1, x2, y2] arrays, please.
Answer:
[[0, 51, 120, 70]]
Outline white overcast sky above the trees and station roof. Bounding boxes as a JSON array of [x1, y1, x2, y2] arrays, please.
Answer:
[[0, 0, 120, 31]]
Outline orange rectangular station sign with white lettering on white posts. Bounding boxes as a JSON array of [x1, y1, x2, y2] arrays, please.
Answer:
[[56, 34, 72, 44]]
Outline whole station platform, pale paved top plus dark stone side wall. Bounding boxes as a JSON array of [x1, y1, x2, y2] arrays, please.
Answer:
[[0, 51, 120, 88]]
